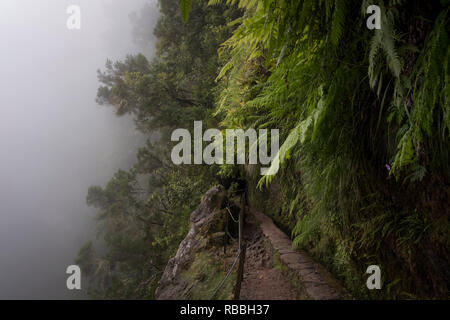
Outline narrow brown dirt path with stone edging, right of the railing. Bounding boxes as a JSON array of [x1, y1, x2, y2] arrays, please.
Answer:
[[240, 211, 348, 300]]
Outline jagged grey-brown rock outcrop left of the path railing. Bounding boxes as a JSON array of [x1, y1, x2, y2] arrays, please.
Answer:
[[155, 186, 226, 300]]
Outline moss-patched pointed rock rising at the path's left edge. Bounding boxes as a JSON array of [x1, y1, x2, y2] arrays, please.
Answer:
[[155, 186, 235, 299]]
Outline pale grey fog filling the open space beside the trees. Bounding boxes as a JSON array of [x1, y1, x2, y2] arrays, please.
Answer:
[[0, 0, 158, 299]]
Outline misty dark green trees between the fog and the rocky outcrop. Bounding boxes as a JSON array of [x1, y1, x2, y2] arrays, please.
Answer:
[[77, 0, 239, 299]]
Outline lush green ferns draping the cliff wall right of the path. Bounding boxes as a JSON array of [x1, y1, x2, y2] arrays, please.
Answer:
[[212, 0, 450, 298]]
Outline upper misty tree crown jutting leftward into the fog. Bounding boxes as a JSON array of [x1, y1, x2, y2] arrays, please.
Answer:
[[97, 0, 239, 132]]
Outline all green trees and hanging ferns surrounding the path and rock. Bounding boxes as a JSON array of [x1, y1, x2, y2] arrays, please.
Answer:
[[76, 0, 450, 299]]
